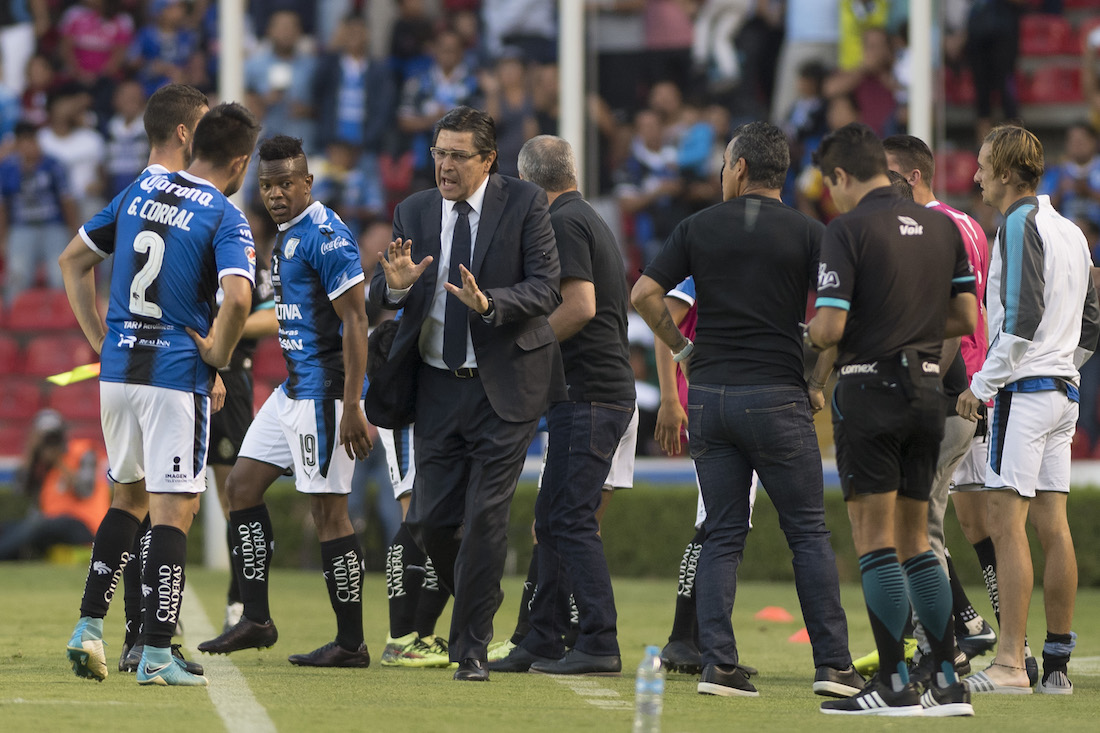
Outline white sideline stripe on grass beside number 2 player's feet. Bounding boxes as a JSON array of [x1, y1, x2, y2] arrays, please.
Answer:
[[180, 595, 275, 733]]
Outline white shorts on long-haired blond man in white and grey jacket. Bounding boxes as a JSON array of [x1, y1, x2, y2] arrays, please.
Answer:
[[986, 390, 1079, 499]]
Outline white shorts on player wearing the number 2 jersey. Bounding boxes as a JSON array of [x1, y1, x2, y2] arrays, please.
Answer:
[[99, 382, 210, 494]]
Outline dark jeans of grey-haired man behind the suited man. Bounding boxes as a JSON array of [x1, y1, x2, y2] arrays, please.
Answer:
[[523, 401, 634, 658]]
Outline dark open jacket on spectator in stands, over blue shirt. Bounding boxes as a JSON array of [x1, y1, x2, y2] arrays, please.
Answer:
[[314, 54, 397, 153]]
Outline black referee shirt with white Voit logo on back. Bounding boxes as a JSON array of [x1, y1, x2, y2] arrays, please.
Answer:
[[817, 187, 975, 367]]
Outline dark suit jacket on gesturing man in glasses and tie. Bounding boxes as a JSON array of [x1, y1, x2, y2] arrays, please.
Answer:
[[366, 174, 565, 428]]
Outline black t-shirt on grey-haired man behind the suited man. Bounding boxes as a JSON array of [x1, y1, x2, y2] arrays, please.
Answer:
[[550, 190, 634, 402]]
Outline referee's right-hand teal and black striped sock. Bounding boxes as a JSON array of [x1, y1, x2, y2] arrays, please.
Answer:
[[902, 550, 956, 687]]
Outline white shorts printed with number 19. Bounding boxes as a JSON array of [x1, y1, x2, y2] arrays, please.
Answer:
[[239, 386, 355, 494]]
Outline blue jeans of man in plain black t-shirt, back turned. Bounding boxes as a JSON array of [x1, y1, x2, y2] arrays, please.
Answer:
[[690, 383, 851, 669]]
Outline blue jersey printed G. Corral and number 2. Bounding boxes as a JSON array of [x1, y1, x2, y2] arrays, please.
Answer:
[[80, 166, 256, 394]]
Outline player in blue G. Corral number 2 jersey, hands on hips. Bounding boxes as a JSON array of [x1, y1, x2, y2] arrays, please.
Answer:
[[59, 103, 260, 686]]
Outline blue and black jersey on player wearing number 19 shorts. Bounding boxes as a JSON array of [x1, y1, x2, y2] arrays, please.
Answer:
[[272, 201, 365, 400]]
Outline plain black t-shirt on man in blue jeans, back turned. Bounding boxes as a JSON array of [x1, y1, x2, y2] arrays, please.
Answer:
[[646, 195, 825, 386]]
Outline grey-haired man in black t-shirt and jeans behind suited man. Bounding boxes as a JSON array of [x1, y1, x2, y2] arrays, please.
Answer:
[[490, 135, 635, 675]]
